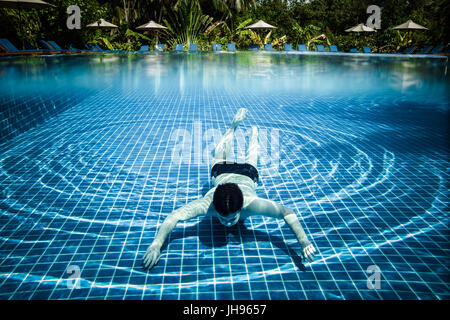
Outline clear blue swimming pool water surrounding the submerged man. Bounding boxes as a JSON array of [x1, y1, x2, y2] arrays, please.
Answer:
[[0, 52, 449, 299]]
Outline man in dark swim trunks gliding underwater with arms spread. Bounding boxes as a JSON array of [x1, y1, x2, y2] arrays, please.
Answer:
[[143, 108, 316, 268]]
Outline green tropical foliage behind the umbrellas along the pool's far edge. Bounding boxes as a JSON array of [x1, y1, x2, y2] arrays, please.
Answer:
[[0, 0, 450, 52]]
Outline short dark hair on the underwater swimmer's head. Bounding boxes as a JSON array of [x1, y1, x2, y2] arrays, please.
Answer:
[[213, 183, 244, 216]]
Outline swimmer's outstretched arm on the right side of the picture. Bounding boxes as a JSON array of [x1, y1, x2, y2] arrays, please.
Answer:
[[247, 198, 316, 262]]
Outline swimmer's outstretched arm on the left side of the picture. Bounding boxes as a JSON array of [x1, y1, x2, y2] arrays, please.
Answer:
[[143, 197, 211, 268]]
